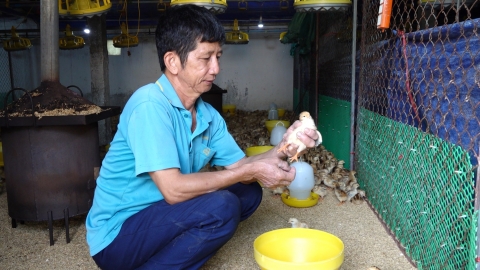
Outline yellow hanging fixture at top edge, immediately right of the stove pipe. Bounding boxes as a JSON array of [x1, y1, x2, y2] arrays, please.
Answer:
[[58, 0, 112, 17]]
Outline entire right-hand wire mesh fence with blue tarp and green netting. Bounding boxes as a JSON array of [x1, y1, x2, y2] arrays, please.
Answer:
[[355, 0, 480, 269]]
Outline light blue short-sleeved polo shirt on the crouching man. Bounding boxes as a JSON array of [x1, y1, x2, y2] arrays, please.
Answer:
[[86, 75, 245, 256]]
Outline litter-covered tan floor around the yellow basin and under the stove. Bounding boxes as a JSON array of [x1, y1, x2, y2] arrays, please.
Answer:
[[0, 186, 416, 270]]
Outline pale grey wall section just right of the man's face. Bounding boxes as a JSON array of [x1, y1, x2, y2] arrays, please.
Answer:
[[216, 34, 293, 111]]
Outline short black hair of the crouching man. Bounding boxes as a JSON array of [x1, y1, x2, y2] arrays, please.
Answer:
[[155, 5, 225, 72]]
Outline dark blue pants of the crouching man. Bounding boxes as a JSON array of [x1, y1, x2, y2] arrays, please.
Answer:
[[93, 182, 262, 270]]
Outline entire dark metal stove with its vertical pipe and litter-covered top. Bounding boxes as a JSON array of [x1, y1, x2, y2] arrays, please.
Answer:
[[0, 0, 120, 245]]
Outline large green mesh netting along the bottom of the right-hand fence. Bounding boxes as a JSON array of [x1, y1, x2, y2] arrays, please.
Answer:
[[356, 109, 478, 270]]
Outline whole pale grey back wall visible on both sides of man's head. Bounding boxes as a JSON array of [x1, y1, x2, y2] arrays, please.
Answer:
[[2, 23, 293, 111]]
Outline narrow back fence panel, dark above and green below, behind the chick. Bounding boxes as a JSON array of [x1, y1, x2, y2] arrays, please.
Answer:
[[316, 9, 353, 168]]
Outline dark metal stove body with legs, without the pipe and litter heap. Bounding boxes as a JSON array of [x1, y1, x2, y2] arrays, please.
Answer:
[[0, 97, 120, 245]]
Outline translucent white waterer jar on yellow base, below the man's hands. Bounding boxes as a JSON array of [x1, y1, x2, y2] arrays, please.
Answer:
[[288, 161, 315, 200]]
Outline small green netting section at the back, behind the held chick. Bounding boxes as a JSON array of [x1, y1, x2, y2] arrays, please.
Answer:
[[317, 95, 351, 168]]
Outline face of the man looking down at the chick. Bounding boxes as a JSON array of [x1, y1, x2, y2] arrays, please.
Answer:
[[178, 42, 222, 94]]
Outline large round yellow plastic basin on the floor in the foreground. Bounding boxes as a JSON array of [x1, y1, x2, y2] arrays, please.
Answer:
[[253, 228, 344, 270]]
